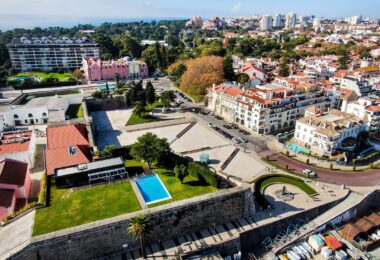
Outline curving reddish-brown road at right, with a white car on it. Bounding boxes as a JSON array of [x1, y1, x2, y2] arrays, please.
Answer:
[[270, 154, 380, 187]]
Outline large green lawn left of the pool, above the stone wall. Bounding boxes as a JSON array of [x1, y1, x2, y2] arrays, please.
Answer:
[[33, 181, 141, 236]]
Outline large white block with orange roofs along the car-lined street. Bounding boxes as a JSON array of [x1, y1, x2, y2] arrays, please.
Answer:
[[208, 81, 334, 134]]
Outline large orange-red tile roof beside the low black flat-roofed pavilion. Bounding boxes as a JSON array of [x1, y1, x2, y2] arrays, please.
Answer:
[[46, 125, 92, 175]]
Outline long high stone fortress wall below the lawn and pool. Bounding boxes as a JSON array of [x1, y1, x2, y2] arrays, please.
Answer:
[[12, 187, 253, 260]]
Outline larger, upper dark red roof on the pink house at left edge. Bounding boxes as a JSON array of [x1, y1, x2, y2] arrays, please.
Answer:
[[0, 158, 29, 186]]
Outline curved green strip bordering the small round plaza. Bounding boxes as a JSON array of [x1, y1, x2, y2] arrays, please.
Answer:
[[253, 174, 317, 209]]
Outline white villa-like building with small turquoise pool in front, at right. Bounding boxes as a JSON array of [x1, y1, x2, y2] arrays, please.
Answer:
[[294, 109, 368, 156]]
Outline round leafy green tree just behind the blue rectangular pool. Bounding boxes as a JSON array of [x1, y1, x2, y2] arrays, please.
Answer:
[[131, 132, 171, 169]]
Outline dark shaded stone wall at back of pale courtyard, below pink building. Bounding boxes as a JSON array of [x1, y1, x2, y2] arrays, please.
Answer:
[[85, 96, 127, 113]]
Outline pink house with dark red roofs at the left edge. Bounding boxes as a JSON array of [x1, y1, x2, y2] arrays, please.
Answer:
[[0, 158, 31, 220]]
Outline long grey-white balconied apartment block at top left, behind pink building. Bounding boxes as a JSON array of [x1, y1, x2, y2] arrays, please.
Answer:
[[7, 37, 99, 71]]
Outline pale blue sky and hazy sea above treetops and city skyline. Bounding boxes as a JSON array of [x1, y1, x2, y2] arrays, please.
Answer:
[[0, 0, 380, 30]]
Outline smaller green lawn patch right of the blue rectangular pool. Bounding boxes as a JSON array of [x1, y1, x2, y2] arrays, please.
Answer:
[[149, 169, 218, 208]]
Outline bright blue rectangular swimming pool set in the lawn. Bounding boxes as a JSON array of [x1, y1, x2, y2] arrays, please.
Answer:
[[135, 174, 172, 204]]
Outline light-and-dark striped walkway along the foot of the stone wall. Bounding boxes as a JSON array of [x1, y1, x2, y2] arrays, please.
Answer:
[[112, 217, 257, 260]]
